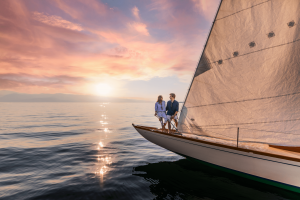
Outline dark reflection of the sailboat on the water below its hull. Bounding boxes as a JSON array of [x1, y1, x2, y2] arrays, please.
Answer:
[[133, 159, 299, 200]]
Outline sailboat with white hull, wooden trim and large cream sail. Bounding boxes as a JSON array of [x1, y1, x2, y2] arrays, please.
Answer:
[[133, 0, 300, 193]]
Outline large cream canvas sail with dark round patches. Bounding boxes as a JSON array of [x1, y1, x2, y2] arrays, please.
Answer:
[[178, 0, 300, 146]]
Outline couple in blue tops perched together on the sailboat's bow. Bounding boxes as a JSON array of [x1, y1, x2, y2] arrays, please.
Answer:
[[154, 93, 179, 132]]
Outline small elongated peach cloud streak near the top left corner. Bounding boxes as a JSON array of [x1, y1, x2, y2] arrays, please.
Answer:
[[33, 12, 83, 31]]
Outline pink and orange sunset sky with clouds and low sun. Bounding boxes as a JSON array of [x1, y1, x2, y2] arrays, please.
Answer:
[[0, 0, 220, 100]]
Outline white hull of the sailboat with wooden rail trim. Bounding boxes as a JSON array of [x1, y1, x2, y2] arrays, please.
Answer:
[[134, 126, 300, 192]]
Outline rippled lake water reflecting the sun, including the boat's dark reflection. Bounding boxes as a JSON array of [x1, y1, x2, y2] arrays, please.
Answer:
[[0, 103, 300, 200]]
